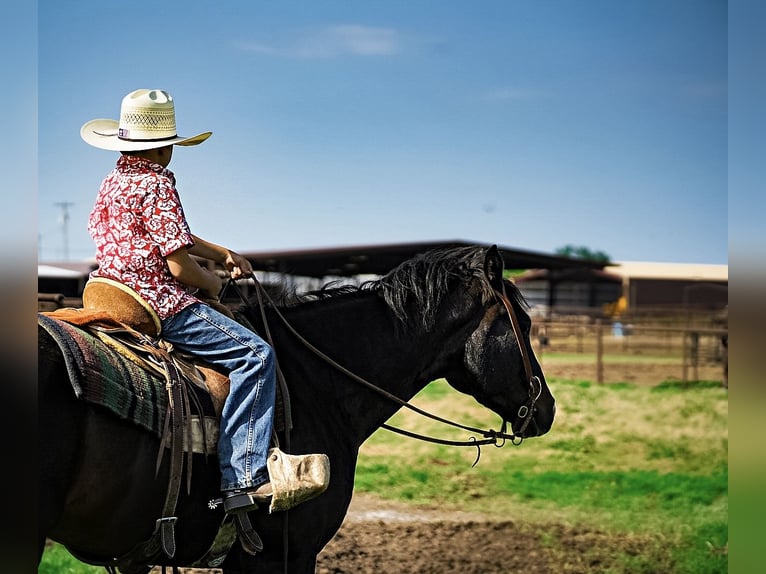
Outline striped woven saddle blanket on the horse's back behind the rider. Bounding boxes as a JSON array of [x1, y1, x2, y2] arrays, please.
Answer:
[[37, 313, 168, 436]]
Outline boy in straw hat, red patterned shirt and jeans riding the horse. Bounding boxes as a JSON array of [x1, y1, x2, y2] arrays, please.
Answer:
[[80, 89, 276, 512]]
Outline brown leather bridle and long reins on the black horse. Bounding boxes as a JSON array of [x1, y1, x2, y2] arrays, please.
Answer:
[[218, 275, 542, 466]]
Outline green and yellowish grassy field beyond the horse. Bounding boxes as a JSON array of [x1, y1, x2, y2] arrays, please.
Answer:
[[40, 356, 728, 574]]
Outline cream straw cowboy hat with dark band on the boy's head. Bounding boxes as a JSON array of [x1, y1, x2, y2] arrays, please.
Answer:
[[80, 90, 213, 151]]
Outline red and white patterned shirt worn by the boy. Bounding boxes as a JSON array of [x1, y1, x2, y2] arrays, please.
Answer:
[[88, 155, 198, 319]]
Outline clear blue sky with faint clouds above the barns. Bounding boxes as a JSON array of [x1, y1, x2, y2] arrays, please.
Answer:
[[37, 0, 728, 263]]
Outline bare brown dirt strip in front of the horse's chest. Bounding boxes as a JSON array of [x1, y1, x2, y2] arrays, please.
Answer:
[[165, 494, 672, 574]]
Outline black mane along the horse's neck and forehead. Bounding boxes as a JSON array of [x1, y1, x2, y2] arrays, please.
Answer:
[[252, 246, 528, 331]]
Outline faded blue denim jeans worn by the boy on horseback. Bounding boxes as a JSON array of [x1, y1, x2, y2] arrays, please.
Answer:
[[162, 303, 276, 490]]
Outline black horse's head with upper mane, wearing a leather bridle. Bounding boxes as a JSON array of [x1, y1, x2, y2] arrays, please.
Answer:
[[377, 246, 556, 438]]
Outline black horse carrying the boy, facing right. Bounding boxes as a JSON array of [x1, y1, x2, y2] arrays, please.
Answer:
[[38, 247, 555, 574]]
